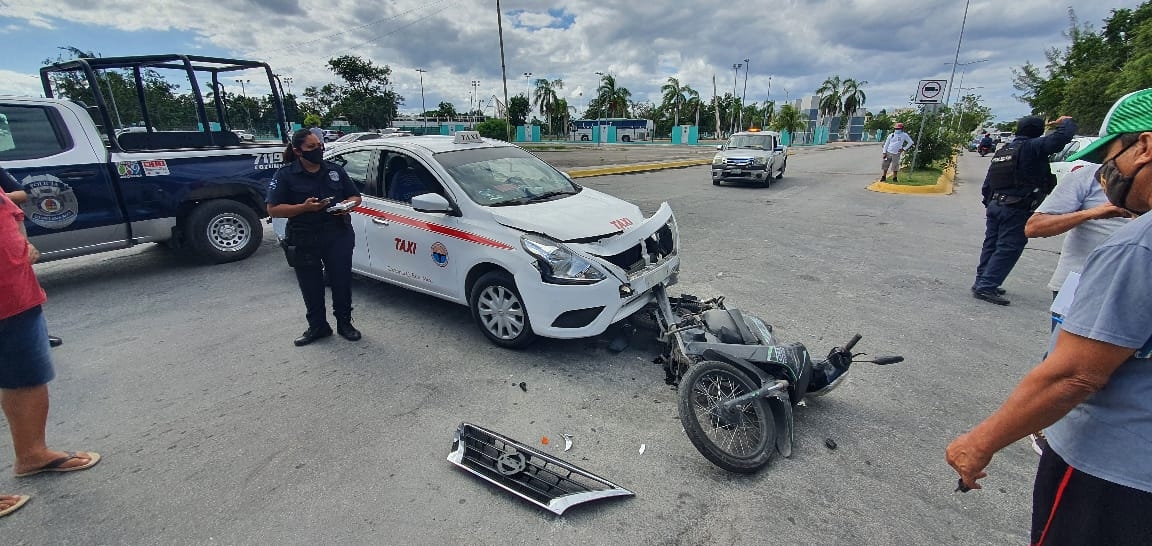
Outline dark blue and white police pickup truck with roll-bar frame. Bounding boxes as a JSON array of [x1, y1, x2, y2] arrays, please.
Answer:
[[0, 55, 286, 263]]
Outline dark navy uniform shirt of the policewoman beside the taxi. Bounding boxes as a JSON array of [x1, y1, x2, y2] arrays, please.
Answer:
[[266, 161, 361, 227]]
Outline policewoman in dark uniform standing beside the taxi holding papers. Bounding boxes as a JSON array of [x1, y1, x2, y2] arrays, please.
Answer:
[[267, 129, 361, 347]]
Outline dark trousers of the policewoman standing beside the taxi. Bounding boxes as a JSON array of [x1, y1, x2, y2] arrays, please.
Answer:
[[296, 226, 356, 329]]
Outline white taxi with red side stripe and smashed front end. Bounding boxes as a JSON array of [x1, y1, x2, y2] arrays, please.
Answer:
[[276, 131, 680, 348]]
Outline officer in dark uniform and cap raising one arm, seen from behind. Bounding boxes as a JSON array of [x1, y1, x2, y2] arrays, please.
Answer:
[[972, 115, 1076, 305]]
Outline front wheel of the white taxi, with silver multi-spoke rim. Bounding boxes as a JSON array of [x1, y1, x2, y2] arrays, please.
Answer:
[[469, 271, 536, 349]]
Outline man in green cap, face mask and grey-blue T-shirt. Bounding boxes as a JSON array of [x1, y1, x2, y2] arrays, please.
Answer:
[[946, 89, 1152, 545]]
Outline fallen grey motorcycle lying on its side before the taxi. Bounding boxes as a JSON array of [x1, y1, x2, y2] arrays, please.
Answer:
[[654, 287, 904, 473]]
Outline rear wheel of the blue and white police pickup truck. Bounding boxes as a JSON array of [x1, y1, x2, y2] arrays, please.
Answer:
[[184, 199, 264, 264]]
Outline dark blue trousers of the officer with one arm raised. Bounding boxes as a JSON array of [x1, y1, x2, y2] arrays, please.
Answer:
[[972, 202, 1032, 291]]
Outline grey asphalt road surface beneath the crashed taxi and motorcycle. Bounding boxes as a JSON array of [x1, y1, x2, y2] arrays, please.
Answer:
[[0, 146, 1059, 545]]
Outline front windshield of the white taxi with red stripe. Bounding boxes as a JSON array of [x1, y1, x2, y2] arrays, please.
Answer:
[[435, 146, 581, 206]]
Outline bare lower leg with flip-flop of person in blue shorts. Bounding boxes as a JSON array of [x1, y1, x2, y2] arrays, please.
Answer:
[[0, 385, 91, 473]]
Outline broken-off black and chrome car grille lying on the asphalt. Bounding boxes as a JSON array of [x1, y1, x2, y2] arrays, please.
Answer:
[[448, 423, 634, 515]]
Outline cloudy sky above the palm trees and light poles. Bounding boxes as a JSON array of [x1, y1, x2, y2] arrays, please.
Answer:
[[0, 0, 1140, 120]]
